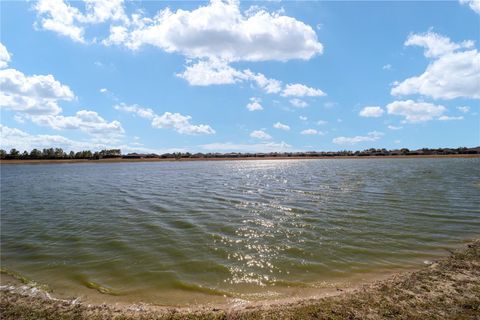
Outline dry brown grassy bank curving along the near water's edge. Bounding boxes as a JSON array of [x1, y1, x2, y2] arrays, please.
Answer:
[[0, 239, 480, 319]]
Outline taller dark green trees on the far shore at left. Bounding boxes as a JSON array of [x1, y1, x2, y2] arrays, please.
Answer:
[[0, 148, 122, 160]]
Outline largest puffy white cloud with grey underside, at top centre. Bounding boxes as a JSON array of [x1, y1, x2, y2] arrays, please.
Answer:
[[106, 1, 323, 62]]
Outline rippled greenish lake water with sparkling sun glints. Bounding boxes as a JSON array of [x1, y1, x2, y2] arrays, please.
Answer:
[[1, 158, 480, 305]]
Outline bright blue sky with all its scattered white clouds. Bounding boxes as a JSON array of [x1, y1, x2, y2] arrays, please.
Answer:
[[0, 0, 480, 153]]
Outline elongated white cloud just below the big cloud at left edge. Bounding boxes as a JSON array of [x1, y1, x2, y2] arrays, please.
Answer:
[[29, 110, 124, 139]]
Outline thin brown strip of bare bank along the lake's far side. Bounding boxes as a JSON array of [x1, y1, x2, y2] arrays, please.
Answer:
[[0, 154, 480, 165]]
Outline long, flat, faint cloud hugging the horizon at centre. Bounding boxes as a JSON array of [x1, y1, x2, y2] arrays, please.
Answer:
[[200, 141, 292, 152]]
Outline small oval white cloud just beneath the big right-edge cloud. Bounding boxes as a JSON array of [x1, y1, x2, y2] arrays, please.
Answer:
[[386, 100, 447, 123]]
